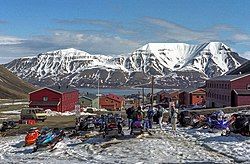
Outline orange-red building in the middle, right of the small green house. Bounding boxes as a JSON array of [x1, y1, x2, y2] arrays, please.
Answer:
[[100, 94, 125, 111]]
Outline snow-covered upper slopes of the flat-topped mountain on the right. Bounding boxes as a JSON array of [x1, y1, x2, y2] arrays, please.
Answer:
[[125, 42, 241, 77]]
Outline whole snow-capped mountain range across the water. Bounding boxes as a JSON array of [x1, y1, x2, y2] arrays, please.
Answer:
[[5, 42, 245, 87]]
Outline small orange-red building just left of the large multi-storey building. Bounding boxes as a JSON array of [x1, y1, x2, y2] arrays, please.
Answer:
[[179, 88, 206, 105]]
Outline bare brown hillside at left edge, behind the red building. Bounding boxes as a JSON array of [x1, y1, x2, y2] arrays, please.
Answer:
[[0, 65, 34, 99]]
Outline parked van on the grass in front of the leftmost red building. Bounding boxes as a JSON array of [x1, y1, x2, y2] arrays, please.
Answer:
[[20, 108, 47, 121]]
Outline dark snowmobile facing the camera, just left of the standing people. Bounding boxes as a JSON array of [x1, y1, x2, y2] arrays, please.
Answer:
[[103, 116, 124, 138]]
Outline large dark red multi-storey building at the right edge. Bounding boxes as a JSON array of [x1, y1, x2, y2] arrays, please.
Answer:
[[206, 74, 250, 107]]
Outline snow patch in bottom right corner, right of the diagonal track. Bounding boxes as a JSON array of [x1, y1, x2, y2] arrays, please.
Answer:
[[176, 128, 250, 162]]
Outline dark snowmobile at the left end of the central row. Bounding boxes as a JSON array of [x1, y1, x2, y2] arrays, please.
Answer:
[[76, 116, 95, 131]]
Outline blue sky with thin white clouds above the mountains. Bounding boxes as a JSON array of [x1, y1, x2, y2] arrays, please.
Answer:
[[0, 0, 250, 63]]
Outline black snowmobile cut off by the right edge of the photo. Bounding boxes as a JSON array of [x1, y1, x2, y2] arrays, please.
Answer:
[[230, 113, 250, 136]]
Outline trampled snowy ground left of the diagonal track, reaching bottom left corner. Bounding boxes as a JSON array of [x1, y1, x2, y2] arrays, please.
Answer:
[[0, 130, 236, 164]]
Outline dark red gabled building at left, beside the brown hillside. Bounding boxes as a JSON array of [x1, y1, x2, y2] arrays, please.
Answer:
[[29, 87, 79, 112]]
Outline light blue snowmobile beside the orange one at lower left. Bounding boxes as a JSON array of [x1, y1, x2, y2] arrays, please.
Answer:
[[33, 128, 65, 152]]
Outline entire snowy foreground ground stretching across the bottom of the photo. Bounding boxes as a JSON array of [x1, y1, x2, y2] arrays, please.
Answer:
[[0, 126, 250, 163]]
